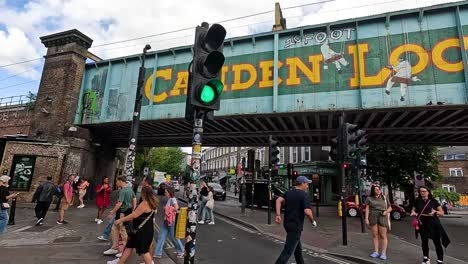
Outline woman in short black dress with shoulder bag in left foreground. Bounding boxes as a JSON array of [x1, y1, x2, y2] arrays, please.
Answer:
[[107, 186, 159, 264]]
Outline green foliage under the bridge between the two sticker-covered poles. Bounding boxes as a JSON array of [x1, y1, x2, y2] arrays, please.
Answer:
[[135, 147, 185, 175]]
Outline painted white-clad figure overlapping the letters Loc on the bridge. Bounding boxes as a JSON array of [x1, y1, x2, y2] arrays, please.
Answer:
[[385, 57, 421, 102]]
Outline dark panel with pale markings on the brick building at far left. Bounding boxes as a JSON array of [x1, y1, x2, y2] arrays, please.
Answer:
[[10, 156, 36, 192]]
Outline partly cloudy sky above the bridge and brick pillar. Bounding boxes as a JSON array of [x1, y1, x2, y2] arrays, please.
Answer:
[[0, 0, 456, 102]]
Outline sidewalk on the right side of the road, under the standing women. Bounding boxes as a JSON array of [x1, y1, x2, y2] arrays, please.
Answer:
[[215, 193, 466, 264]]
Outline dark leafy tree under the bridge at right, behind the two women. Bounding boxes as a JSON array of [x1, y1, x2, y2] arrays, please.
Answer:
[[366, 145, 441, 202]]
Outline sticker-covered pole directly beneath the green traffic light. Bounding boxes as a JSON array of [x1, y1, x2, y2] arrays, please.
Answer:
[[184, 110, 205, 264]]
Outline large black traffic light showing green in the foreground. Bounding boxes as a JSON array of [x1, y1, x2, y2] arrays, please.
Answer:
[[187, 22, 226, 111]]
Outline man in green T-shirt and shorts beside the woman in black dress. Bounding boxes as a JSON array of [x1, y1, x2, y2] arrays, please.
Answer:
[[103, 176, 137, 257]]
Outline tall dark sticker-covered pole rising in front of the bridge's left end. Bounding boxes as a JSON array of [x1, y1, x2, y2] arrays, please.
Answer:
[[125, 44, 151, 183]]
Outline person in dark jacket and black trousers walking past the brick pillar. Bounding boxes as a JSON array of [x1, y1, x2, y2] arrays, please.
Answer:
[[33, 176, 57, 226]]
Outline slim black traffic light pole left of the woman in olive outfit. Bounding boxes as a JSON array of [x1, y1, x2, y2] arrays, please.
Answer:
[[338, 113, 348, 246]]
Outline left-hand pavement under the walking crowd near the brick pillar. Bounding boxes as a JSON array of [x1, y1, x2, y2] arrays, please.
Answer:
[[0, 199, 176, 264]]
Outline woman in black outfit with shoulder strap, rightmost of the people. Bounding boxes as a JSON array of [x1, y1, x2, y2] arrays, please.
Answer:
[[411, 186, 450, 264]]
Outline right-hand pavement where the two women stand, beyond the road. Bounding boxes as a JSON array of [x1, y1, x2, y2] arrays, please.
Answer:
[[186, 193, 468, 264]]
